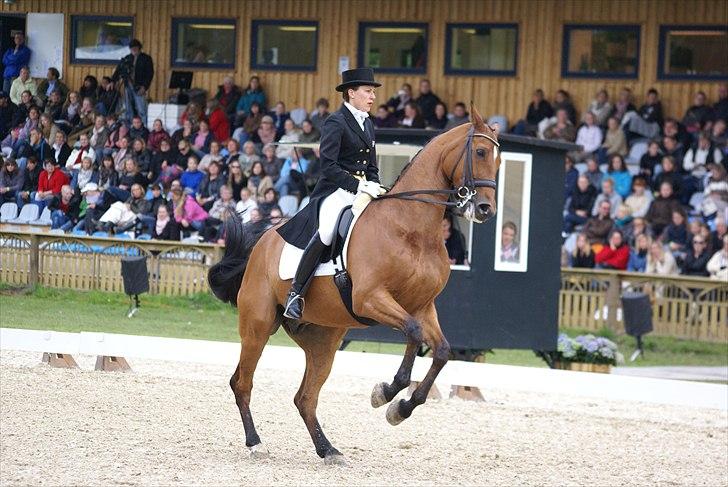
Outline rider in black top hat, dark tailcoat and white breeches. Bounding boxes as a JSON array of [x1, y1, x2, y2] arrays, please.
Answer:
[[278, 68, 385, 319]]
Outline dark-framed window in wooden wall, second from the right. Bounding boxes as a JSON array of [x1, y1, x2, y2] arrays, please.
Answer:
[[561, 25, 640, 79]]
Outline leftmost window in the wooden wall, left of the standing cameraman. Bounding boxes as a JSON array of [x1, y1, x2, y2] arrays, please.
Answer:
[[71, 15, 134, 64]]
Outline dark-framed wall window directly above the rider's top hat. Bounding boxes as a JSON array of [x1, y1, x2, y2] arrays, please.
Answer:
[[357, 23, 427, 73]]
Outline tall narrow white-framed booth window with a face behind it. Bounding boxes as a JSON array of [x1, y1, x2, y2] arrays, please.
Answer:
[[495, 152, 531, 272]]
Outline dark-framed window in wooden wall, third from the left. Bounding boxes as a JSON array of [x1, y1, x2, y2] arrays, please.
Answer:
[[250, 20, 318, 71]]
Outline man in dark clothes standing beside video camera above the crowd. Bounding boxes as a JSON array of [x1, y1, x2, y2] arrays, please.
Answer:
[[112, 39, 154, 122]]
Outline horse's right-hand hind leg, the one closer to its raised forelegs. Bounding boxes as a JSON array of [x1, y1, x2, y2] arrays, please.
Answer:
[[290, 324, 346, 464]]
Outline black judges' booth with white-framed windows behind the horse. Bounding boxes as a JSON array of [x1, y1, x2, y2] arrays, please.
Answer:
[[346, 129, 577, 351]]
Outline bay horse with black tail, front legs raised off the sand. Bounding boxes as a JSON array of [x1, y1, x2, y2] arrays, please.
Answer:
[[208, 104, 500, 464]]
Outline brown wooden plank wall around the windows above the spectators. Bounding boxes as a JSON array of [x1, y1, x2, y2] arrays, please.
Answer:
[[0, 0, 728, 126]]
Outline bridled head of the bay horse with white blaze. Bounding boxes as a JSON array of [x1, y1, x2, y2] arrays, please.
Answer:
[[441, 103, 501, 223]]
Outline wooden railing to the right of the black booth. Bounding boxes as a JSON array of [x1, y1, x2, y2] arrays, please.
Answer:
[[559, 269, 728, 342]]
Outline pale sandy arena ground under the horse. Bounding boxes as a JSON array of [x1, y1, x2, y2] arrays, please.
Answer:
[[0, 351, 728, 486]]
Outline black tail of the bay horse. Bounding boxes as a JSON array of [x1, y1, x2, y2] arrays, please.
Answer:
[[207, 211, 258, 306]]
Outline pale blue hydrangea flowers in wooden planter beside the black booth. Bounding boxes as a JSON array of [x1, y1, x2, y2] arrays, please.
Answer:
[[554, 333, 624, 374]]
